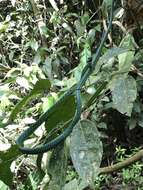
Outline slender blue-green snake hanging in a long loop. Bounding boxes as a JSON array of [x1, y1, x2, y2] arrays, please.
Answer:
[[16, 0, 114, 154]]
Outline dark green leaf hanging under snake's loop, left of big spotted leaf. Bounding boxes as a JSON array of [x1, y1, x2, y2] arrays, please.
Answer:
[[47, 143, 68, 190]]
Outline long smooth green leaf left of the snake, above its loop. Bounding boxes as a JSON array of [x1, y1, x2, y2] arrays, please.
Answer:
[[8, 79, 50, 123]]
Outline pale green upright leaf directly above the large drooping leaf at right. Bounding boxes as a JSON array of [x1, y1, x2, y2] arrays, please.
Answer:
[[118, 34, 135, 72]]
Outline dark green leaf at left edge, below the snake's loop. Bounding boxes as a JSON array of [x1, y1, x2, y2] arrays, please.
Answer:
[[0, 145, 21, 187]]
